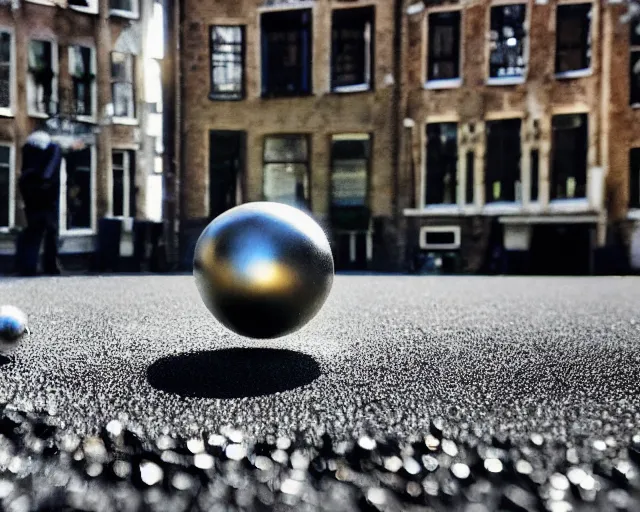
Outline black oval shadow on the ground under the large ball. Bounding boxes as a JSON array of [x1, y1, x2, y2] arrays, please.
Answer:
[[147, 348, 321, 398]]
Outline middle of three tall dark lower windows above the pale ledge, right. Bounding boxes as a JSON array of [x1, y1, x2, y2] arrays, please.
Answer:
[[484, 119, 522, 203]]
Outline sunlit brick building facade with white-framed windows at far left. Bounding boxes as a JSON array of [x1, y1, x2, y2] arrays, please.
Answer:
[[0, 0, 162, 271]]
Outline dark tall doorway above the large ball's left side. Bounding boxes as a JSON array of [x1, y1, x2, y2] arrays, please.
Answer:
[[209, 130, 246, 219]]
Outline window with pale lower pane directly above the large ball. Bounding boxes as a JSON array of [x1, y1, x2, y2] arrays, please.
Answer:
[[263, 135, 309, 208]]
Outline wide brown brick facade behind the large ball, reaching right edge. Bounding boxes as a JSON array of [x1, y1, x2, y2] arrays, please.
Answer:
[[172, 0, 640, 273]]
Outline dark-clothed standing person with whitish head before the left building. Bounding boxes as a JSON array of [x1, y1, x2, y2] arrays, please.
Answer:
[[17, 131, 62, 276]]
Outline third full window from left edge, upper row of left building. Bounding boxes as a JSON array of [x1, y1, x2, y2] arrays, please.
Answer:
[[69, 46, 96, 117]]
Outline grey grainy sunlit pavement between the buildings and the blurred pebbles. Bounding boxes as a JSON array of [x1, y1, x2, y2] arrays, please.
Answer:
[[0, 275, 640, 510]]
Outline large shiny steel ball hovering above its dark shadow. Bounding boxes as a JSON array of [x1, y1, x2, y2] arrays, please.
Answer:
[[193, 202, 334, 339]]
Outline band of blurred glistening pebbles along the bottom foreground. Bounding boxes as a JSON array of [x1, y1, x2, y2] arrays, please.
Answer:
[[0, 406, 640, 512]]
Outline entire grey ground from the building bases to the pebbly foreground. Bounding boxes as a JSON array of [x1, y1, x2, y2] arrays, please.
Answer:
[[0, 276, 640, 512]]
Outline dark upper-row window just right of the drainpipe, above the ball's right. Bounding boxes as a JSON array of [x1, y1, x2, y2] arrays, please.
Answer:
[[427, 11, 460, 80]]
